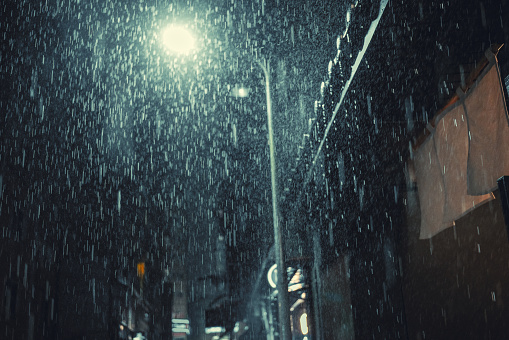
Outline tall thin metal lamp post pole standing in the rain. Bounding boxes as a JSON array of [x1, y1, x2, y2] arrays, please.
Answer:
[[255, 60, 291, 340]]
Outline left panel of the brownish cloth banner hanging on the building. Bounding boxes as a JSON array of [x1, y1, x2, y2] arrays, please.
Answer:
[[414, 103, 492, 239]]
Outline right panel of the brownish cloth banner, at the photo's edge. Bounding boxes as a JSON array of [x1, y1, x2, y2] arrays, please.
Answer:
[[464, 55, 509, 195]]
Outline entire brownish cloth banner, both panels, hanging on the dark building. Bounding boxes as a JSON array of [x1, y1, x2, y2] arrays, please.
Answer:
[[414, 53, 509, 239]]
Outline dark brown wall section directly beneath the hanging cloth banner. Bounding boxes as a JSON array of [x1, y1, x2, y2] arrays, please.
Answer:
[[403, 191, 509, 339]]
